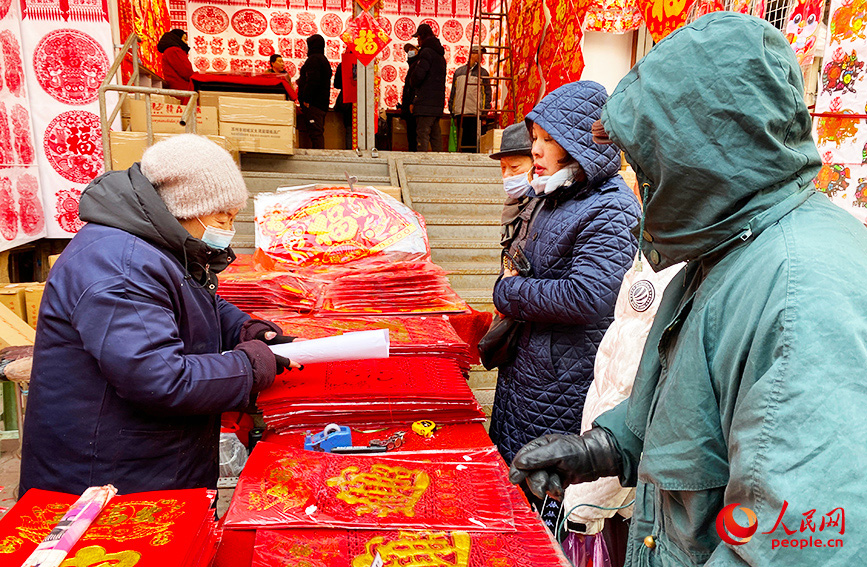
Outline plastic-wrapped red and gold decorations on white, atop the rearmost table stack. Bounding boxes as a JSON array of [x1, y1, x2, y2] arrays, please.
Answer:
[[255, 187, 430, 266]]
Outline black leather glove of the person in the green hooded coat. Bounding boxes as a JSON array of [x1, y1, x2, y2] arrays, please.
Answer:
[[509, 427, 623, 500]]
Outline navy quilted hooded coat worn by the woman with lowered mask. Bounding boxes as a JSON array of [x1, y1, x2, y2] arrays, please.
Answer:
[[490, 81, 639, 462]]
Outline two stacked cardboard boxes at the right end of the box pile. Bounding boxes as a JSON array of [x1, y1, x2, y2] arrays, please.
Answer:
[[219, 96, 295, 155]]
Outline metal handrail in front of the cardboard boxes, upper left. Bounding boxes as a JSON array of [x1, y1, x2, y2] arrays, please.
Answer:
[[99, 33, 199, 171]]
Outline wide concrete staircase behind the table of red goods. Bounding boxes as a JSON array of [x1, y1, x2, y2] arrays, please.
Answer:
[[239, 150, 504, 414]]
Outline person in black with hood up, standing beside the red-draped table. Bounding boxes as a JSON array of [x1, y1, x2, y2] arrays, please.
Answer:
[[298, 33, 331, 150]]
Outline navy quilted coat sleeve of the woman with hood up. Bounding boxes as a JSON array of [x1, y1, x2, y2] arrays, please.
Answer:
[[494, 199, 638, 325]]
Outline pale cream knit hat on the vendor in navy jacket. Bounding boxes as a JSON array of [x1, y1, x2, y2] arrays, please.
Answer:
[[141, 134, 249, 219]]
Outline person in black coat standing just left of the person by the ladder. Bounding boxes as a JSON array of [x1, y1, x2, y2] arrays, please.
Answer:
[[407, 24, 446, 152]]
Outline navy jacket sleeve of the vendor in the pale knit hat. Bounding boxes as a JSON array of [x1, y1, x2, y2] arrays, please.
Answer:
[[71, 276, 253, 415]]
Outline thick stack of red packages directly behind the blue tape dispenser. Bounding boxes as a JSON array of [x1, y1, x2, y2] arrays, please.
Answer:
[[258, 356, 485, 431]]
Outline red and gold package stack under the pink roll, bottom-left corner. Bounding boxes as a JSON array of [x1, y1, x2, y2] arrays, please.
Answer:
[[0, 488, 219, 567]]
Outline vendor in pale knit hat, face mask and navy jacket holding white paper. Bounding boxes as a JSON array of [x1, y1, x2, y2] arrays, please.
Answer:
[[19, 134, 297, 496]]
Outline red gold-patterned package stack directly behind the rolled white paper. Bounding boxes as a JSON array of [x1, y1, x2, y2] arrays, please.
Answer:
[[251, 310, 472, 372]]
